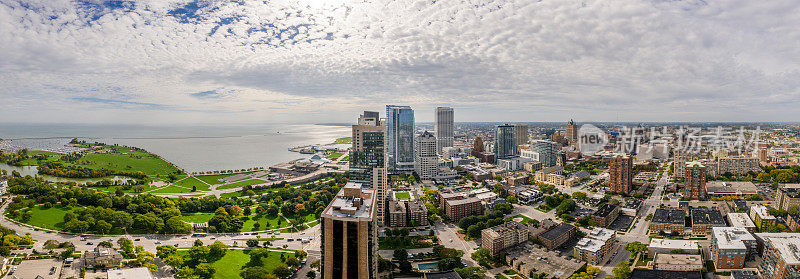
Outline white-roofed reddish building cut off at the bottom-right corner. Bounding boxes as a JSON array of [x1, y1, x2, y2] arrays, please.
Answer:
[[756, 233, 800, 279]]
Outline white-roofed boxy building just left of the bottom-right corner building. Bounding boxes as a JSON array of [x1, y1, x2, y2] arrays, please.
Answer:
[[710, 227, 758, 269]]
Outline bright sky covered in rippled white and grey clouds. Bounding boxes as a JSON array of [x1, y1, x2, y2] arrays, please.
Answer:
[[0, 0, 800, 123]]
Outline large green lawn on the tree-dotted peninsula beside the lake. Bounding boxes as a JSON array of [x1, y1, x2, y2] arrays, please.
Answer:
[[75, 147, 180, 176]]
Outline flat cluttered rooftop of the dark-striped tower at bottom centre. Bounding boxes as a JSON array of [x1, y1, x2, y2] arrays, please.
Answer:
[[322, 182, 376, 219]]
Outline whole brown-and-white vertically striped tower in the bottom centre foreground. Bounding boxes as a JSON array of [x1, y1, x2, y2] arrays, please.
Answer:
[[320, 182, 378, 279]]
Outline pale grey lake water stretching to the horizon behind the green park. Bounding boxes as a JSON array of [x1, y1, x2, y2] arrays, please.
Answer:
[[0, 124, 351, 172]]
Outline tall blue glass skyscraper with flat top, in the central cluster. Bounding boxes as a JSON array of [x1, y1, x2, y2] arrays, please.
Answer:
[[386, 105, 414, 171]]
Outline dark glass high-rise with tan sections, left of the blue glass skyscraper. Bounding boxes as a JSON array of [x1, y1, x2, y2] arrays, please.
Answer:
[[349, 111, 388, 223]]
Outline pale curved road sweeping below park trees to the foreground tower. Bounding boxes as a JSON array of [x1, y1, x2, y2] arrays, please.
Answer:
[[0, 202, 320, 253]]
